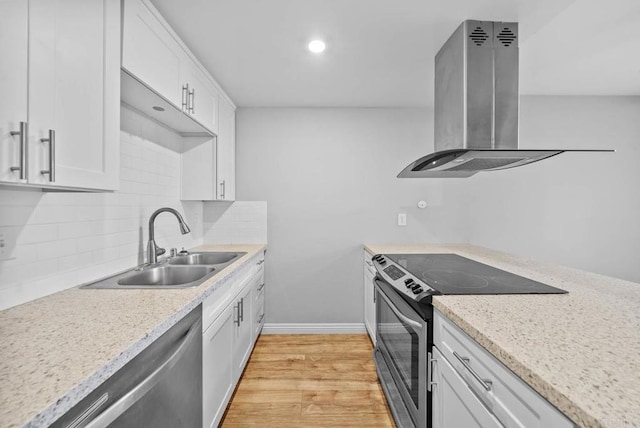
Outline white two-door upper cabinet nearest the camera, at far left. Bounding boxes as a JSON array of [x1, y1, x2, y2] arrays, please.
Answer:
[[0, 0, 120, 190]]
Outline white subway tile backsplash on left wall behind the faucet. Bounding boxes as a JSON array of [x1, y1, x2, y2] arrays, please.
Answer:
[[0, 109, 202, 309]]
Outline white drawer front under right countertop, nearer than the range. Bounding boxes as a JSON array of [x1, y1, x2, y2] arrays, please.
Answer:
[[433, 310, 574, 428]]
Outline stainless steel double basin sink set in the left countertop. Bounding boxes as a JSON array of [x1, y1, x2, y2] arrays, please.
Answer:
[[80, 252, 246, 289]]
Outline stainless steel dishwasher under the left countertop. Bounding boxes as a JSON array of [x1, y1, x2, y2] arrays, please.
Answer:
[[52, 305, 202, 428]]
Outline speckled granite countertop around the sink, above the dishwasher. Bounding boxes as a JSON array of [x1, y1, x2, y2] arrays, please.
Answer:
[[0, 245, 265, 427]]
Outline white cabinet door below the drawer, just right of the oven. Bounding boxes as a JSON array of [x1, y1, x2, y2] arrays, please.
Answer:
[[431, 347, 502, 428]]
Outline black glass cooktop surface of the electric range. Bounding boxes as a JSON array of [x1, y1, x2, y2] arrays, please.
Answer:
[[385, 254, 567, 294]]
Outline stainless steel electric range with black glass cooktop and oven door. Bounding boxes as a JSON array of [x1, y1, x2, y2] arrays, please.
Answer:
[[373, 254, 566, 428]]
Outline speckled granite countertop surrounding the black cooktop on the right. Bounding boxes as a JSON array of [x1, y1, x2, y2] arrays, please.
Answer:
[[365, 244, 640, 428]]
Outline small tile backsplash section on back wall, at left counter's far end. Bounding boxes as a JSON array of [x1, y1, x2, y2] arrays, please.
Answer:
[[203, 201, 267, 244]]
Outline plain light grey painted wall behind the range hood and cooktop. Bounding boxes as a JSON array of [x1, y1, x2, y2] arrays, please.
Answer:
[[237, 97, 640, 323]]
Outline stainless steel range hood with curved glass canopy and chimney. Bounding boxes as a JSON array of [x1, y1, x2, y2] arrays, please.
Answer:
[[398, 20, 613, 178]]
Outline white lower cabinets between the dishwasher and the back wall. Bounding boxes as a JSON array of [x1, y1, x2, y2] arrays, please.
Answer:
[[202, 253, 264, 428]]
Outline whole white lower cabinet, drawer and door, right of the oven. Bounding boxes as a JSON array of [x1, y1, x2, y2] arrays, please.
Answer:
[[431, 310, 574, 428]]
